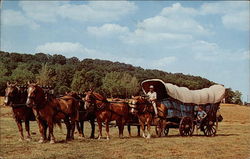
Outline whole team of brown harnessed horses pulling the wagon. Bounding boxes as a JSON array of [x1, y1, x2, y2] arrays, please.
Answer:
[[4, 83, 167, 143]]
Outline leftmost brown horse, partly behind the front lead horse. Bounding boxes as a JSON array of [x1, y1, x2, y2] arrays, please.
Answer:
[[4, 82, 35, 141]]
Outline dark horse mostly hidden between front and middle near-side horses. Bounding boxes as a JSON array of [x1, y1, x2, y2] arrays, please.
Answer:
[[67, 92, 96, 138]]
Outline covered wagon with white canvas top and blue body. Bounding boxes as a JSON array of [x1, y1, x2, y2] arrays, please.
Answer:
[[141, 79, 225, 136]]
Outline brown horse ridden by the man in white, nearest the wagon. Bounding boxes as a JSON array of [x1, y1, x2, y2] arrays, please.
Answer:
[[129, 96, 167, 139]]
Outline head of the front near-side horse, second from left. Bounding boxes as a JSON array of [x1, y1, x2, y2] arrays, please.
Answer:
[[26, 82, 45, 108]]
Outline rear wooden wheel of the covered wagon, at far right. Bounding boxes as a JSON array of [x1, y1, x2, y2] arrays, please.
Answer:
[[202, 119, 218, 136]]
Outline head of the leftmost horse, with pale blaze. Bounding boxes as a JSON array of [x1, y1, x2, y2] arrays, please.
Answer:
[[4, 82, 18, 105]]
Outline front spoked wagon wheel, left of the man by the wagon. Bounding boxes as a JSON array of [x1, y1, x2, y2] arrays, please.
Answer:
[[179, 117, 194, 136]]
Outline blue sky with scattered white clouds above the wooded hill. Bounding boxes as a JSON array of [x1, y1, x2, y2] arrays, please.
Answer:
[[1, 1, 250, 102]]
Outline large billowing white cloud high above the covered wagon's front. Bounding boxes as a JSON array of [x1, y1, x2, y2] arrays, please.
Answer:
[[122, 3, 211, 44]]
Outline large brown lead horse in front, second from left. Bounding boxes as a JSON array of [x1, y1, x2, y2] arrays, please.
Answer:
[[26, 84, 78, 143]]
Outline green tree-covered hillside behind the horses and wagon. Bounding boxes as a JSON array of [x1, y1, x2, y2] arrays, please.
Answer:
[[0, 51, 240, 103]]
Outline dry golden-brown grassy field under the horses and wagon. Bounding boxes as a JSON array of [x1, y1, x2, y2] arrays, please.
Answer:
[[0, 97, 250, 159]]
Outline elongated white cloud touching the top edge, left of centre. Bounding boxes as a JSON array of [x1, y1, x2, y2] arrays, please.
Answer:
[[58, 1, 137, 22]]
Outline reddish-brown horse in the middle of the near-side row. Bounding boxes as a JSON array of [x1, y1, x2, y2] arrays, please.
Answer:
[[85, 91, 129, 140]]
